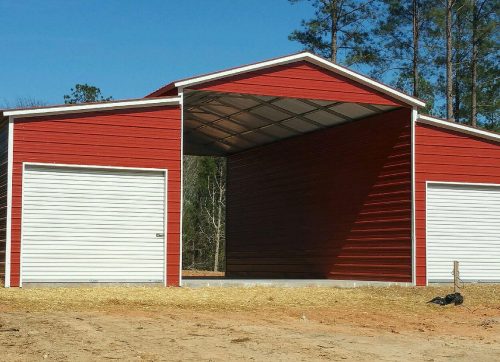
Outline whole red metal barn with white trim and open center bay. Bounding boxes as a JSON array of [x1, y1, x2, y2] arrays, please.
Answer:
[[0, 53, 500, 286]]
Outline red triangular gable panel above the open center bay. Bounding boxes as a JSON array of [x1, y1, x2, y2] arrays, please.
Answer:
[[190, 62, 400, 105]]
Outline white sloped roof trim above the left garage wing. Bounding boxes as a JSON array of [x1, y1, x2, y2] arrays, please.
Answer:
[[3, 97, 181, 118]]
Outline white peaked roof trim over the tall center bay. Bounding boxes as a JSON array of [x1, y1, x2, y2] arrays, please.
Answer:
[[174, 52, 425, 107]]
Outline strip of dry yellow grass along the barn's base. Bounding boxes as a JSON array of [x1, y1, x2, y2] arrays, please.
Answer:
[[0, 285, 500, 314]]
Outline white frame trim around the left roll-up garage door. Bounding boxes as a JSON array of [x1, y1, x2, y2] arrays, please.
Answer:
[[19, 162, 168, 287]]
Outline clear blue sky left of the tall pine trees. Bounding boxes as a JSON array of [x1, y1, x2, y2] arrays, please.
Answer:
[[0, 0, 313, 107]]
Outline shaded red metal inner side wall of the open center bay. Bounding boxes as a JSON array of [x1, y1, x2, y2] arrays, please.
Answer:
[[226, 109, 412, 282]]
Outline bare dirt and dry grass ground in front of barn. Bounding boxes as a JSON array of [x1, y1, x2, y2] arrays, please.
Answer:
[[0, 286, 500, 361]]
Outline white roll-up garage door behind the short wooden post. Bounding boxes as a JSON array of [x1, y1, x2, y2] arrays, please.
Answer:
[[427, 183, 500, 282]]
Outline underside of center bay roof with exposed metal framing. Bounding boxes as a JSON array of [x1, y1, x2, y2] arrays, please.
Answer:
[[184, 90, 398, 156]]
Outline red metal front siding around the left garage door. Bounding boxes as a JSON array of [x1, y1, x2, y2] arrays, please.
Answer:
[[11, 106, 181, 286]]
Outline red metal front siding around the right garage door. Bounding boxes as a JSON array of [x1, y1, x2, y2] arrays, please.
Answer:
[[415, 123, 500, 285]]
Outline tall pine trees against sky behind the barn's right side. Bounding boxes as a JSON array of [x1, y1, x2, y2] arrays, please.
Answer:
[[289, 0, 500, 131]]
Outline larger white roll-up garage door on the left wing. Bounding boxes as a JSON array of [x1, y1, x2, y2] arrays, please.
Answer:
[[21, 165, 166, 283]]
